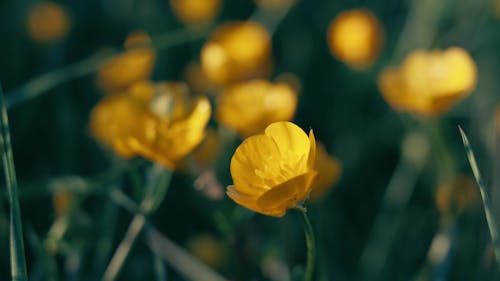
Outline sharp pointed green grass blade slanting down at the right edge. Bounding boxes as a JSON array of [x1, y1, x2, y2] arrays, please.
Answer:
[[458, 126, 500, 270]]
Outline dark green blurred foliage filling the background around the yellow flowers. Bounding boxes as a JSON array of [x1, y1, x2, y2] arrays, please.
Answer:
[[0, 0, 500, 281]]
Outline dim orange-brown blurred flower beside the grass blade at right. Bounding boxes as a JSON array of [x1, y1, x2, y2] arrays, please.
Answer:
[[436, 176, 480, 215]]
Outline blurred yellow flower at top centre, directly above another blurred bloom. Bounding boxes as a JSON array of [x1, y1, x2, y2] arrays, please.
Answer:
[[201, 21, 271, 85]]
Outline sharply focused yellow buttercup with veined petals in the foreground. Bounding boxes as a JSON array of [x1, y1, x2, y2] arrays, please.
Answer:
[[227, 122, 317, 217]]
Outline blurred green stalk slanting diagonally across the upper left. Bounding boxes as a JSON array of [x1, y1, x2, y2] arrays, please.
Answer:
[[6, 28, 210, 108]]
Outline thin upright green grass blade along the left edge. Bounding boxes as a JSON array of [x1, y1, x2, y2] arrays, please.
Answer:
[[0, 85, 28, 281]]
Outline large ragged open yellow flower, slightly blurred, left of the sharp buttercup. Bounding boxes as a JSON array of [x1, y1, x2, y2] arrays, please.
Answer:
[[90, 82, 211, 169]]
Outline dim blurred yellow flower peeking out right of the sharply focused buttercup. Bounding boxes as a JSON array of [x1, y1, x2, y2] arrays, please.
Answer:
[[308, 143, 342, 202]]
